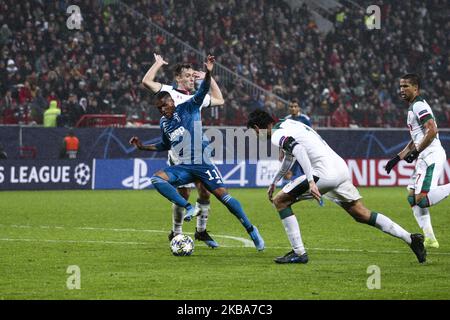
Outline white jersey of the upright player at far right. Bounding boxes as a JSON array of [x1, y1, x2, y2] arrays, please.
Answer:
[[407, 96, 442, 157]]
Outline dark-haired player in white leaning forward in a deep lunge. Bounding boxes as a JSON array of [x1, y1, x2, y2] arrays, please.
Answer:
[[247, 110, 426, 263]]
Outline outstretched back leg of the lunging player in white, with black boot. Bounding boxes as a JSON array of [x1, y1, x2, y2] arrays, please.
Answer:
[[340, 200, 427, 263]]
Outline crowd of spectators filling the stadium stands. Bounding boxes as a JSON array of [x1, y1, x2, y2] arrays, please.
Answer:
[[0, 0, 450, 127]]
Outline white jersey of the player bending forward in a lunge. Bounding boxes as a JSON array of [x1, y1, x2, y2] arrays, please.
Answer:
[[271, 119, 348, 178]]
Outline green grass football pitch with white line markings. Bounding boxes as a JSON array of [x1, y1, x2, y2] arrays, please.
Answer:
[[0, 188, 450, 300]]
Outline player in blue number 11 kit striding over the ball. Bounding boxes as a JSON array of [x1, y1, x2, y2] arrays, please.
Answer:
[[130, 56, 264, 251]]
